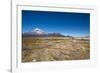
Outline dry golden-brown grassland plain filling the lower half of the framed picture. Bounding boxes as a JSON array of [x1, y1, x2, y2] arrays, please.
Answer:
[[22, 37, 90, 63]]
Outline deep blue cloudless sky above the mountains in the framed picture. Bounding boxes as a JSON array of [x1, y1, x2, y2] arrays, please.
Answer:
[[22, 10, 90, 36]]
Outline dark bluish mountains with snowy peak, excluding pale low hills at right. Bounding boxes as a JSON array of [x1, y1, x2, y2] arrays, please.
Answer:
[[22, 28, 65, 37]]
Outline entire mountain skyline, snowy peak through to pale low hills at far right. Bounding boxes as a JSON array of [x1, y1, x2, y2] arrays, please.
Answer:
[[22, 28, 90, 39]]
